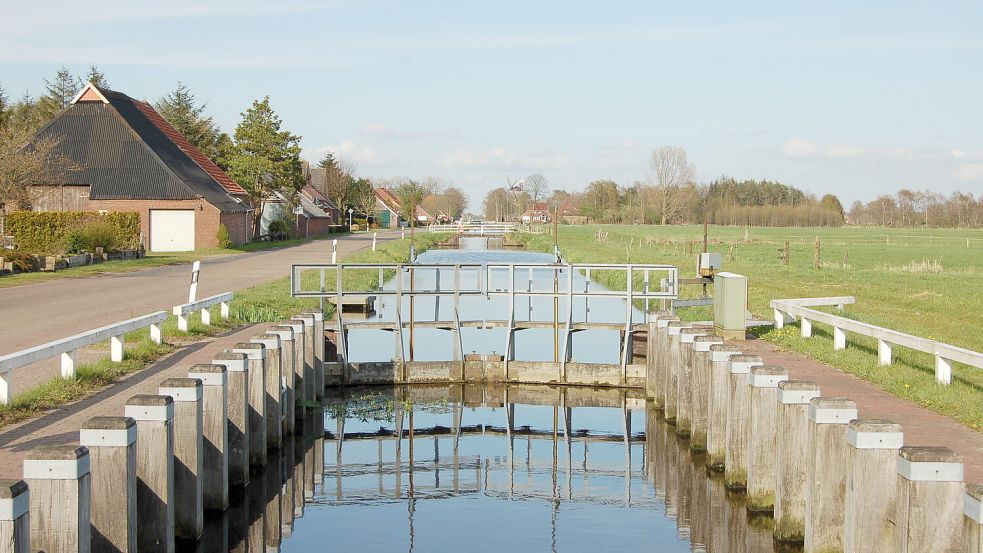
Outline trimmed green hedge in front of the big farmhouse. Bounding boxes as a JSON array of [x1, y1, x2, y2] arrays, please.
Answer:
[[5, 211, 140, 254]]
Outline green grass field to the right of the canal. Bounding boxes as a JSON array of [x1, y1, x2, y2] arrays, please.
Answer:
[[524, 225, 983, 429]]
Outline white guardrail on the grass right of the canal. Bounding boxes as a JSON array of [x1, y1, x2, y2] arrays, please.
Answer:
[[770, 296, 983, 384]]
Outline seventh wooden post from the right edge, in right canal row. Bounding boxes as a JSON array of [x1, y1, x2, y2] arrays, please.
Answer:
[[724, 355, 764, 490]]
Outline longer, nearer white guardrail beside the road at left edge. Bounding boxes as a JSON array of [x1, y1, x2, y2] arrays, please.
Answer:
[[0, 311, 167, 405]]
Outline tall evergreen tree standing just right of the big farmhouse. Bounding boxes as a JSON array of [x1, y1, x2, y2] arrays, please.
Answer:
[[228, 96, 304, 237]]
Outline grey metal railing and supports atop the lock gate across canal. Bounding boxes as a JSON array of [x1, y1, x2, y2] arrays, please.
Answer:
[[290, 263, 679, 378]]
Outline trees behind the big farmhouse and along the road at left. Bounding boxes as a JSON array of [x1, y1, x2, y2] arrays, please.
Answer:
[[0, 65, 467, 236]]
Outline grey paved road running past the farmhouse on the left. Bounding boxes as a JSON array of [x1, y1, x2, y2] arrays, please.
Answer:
[[0, 231, 399, 394]]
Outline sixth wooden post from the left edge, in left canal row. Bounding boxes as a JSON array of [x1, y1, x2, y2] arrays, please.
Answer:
[[188, 364, 229, 511]]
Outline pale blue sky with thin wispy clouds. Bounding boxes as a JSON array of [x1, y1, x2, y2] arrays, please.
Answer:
[[0, 0, 983, 212]]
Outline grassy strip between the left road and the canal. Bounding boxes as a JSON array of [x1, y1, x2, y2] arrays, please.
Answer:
[[0, 234, 446, 428]]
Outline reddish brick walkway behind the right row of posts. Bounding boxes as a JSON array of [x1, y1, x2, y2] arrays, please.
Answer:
[[745, 334, 983, 482]]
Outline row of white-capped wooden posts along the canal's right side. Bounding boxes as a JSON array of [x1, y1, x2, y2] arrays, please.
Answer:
[[646, 312, 983, 553]]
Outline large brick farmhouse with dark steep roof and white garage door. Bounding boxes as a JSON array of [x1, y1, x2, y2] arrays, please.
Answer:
[[26, 83, 252, 252]]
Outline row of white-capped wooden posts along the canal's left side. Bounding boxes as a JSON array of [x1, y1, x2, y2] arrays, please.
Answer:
[[0, 312, 324, 553]]
